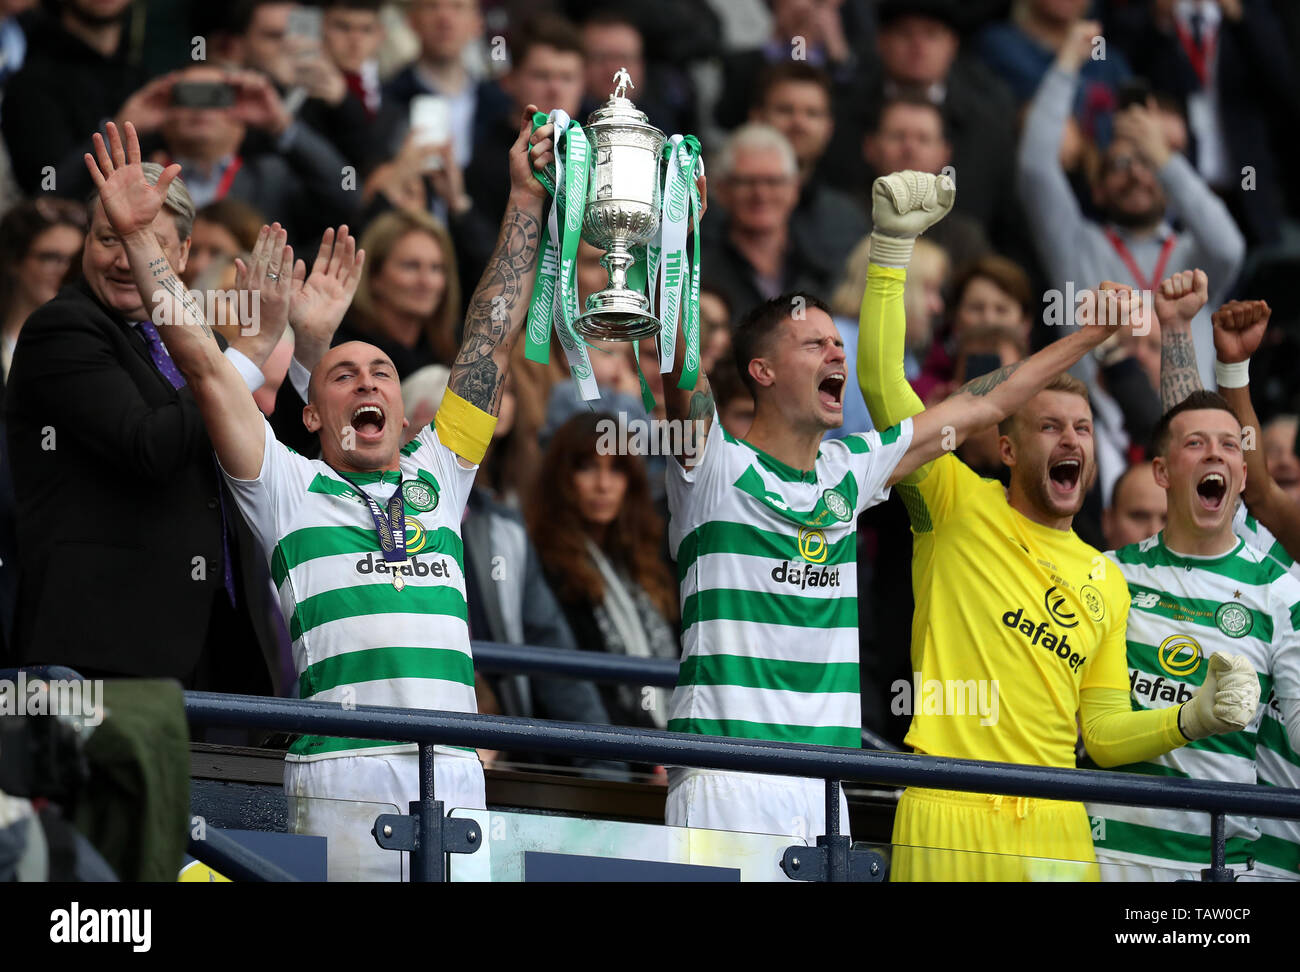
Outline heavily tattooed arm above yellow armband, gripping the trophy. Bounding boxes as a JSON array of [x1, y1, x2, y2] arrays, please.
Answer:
[[447, 105, 554, 467]]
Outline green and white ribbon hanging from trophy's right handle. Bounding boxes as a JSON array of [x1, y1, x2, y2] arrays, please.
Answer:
[[646, 135, 705, 389]]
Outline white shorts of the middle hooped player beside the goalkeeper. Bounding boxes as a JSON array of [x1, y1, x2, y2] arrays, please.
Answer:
[[664, 767, 849, 845]]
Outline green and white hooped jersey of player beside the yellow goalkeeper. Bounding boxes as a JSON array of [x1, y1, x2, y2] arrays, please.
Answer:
[[668, 415, 911, 747]]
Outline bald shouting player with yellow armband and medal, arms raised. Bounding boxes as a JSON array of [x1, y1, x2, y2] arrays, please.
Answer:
[[86, 115, 553, 880]]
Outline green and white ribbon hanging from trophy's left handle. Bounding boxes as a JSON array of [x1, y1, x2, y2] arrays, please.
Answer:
[[524, 109, 601, 402]]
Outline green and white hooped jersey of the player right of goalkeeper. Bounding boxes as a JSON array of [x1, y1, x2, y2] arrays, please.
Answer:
[[1088, 533, 1300, 869]]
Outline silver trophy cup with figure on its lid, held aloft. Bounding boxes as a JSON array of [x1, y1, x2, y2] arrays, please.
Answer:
[[573, 70, 664, 340]]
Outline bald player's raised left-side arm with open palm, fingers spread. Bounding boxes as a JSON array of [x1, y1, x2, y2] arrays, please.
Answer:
[[86, 122, 274, 480]]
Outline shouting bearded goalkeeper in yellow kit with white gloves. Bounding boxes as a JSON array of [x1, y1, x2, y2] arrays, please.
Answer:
[[858, 198, 1253, 881]]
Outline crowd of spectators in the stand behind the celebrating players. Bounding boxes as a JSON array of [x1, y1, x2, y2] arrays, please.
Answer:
[[0, 0, 1300, 755]]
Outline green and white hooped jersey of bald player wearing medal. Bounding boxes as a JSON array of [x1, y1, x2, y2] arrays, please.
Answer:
[[226, 424, 477, 760]]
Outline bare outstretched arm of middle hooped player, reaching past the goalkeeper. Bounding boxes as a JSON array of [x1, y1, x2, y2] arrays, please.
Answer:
[[889, 290, 1141, 485]]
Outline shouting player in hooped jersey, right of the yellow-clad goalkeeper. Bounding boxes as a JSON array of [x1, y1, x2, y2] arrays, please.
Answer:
[[1088, 384, 1300, 881]]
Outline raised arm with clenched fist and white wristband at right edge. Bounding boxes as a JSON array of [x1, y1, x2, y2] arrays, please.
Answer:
[[1212, 300, 1300, 559]]
